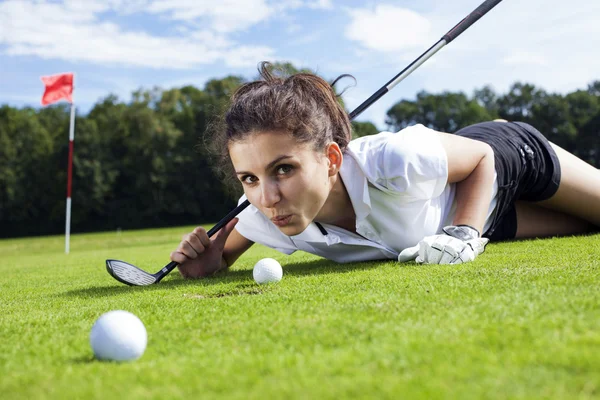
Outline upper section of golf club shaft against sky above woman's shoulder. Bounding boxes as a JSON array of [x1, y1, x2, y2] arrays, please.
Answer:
[[349, 0, 502, 119]]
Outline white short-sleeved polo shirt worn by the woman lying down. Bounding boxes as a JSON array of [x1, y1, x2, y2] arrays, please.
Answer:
[[236, 124, 498, 262]]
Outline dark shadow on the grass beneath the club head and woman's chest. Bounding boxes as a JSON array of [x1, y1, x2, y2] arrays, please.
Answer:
[[63, 259, 386, 298]]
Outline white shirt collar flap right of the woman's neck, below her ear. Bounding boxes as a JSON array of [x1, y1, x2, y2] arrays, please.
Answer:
[[340, 148, 371, 221]]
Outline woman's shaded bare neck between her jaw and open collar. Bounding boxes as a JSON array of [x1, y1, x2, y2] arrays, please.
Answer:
[[315, 173, 356, 232]]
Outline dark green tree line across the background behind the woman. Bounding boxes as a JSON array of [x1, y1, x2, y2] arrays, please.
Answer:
[[0, 65, 600, 237]]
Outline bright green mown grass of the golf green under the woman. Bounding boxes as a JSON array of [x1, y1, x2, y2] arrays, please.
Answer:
[[0, 227, 600, 399]]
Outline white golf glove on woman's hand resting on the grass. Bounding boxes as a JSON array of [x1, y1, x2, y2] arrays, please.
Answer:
[[398, 225, 489, 264]]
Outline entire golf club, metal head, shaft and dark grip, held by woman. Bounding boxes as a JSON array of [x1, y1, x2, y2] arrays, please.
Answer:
[[106, 0, 502, 286]]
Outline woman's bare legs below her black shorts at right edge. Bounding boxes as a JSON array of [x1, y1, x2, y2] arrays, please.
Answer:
[[515, 143, 600, 238]]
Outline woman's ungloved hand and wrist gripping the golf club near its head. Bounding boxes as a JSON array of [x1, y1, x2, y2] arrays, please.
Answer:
[[171, 218, 238, 279]]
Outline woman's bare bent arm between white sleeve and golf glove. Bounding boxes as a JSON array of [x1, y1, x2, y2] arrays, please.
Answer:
[[439, 133, 494, 234]]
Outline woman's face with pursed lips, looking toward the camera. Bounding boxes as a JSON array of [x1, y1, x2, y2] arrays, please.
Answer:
[[229, 132, 336, 236]]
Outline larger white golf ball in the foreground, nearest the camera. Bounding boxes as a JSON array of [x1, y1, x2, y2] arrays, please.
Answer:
[[90, 310, 148, 361]]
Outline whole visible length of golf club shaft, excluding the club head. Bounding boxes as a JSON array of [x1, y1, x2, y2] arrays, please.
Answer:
[[157, 0, 502, 280]]
